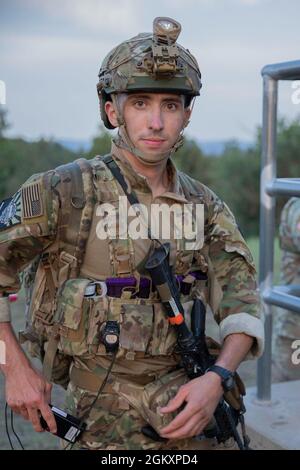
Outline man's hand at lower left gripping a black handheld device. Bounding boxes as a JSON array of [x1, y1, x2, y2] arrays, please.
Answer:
[[6, 366, 57, 433]]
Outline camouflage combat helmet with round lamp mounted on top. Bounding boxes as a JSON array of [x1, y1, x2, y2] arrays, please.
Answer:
[[97, 17, 202, 129]]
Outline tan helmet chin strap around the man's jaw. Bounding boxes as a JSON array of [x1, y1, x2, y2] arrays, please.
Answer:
[[112, 94, 189, 166]]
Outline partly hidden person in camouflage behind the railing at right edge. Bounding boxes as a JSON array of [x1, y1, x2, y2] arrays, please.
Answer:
[[273, 197, 300, 381]]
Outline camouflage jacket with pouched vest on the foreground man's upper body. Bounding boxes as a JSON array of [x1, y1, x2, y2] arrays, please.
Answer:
[[0, 142, 263, 382]]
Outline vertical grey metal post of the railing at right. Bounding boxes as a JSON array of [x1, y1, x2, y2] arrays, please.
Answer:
[[257, 75, 278, 401]]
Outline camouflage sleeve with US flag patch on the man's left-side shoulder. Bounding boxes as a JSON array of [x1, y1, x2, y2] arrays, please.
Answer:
[[0, 168, 59, 322]]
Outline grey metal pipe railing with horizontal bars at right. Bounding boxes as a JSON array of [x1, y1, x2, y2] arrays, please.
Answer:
[[257, 60, 300, 401]]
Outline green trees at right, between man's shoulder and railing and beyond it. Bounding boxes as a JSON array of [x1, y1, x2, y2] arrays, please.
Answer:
[[207, 117, 300, 236]]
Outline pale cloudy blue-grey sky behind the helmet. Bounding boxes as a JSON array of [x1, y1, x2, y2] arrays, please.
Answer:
[[0, 0, 300, 141]]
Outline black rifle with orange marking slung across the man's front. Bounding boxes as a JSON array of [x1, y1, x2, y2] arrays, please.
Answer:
[[143, 243, 249, 450]]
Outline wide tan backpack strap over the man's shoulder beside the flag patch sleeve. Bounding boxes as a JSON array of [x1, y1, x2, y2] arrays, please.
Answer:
[[43, 159, 95, 380]]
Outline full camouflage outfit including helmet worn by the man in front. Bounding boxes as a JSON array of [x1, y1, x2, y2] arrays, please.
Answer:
[[0, 15, 263, 449]]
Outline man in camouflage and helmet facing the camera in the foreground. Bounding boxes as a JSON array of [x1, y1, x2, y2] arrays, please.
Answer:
[[0, 18, 263, 449]]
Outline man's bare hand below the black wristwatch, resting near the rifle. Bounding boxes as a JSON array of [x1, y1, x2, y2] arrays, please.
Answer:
[[160, 372, 223, 439]]
